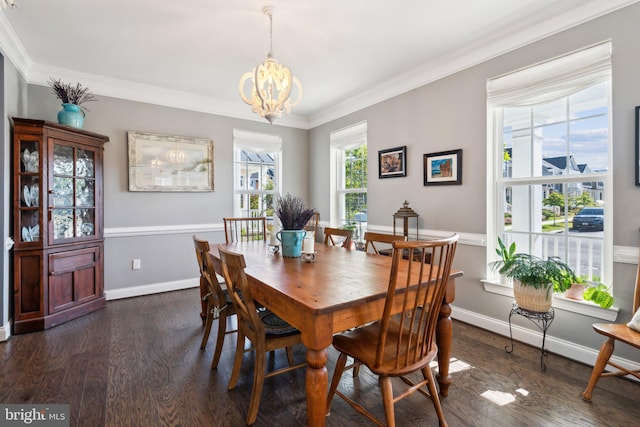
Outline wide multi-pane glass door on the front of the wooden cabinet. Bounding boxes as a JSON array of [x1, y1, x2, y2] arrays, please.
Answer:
[[51, 143, 96, 241]]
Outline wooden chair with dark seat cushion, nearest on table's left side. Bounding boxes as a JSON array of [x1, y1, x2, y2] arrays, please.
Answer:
[[216, 245, 306, 425]]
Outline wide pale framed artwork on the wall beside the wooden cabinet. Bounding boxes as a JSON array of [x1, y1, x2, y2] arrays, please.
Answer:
[[128, 132, 213, 192]]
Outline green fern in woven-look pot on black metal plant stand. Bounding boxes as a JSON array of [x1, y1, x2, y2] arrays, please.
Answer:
[[491, 253, 577, 312]]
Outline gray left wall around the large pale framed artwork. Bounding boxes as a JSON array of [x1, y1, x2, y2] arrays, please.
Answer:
[[29, 85, 309, 294]]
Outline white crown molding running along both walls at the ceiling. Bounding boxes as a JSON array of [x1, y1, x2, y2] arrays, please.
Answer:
[[0, 0, 640, 130]]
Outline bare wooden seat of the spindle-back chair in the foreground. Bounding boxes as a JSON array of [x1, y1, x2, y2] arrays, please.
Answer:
[[333, 316, 438, 376]]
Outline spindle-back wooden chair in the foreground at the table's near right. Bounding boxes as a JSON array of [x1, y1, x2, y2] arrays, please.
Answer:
[[327, 234, 458, 426]]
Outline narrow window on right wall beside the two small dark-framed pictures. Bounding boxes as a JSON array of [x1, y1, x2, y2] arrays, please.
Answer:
[[330, 122, 367, 241]]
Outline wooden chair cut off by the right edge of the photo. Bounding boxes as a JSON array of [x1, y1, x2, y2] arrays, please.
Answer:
[[582, 246, 640, 402]]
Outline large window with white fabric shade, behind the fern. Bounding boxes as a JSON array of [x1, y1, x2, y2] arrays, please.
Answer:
[[487, 43, 613, 283]]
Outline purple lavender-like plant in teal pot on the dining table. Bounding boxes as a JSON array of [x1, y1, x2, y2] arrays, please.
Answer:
[[276, 193, 315, 257]]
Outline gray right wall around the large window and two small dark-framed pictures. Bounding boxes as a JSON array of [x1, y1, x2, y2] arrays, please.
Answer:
[[310, 5, 640, 360]]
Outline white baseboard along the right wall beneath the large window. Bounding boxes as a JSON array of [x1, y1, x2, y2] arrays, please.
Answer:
[[451, 306, 640, 380]]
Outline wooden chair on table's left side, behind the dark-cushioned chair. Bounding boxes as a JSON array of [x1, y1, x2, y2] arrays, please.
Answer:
[[193, 236, 237, 369]]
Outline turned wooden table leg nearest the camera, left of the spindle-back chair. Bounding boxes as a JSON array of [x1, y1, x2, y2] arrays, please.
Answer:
[[306, 349, 329, 427]]
